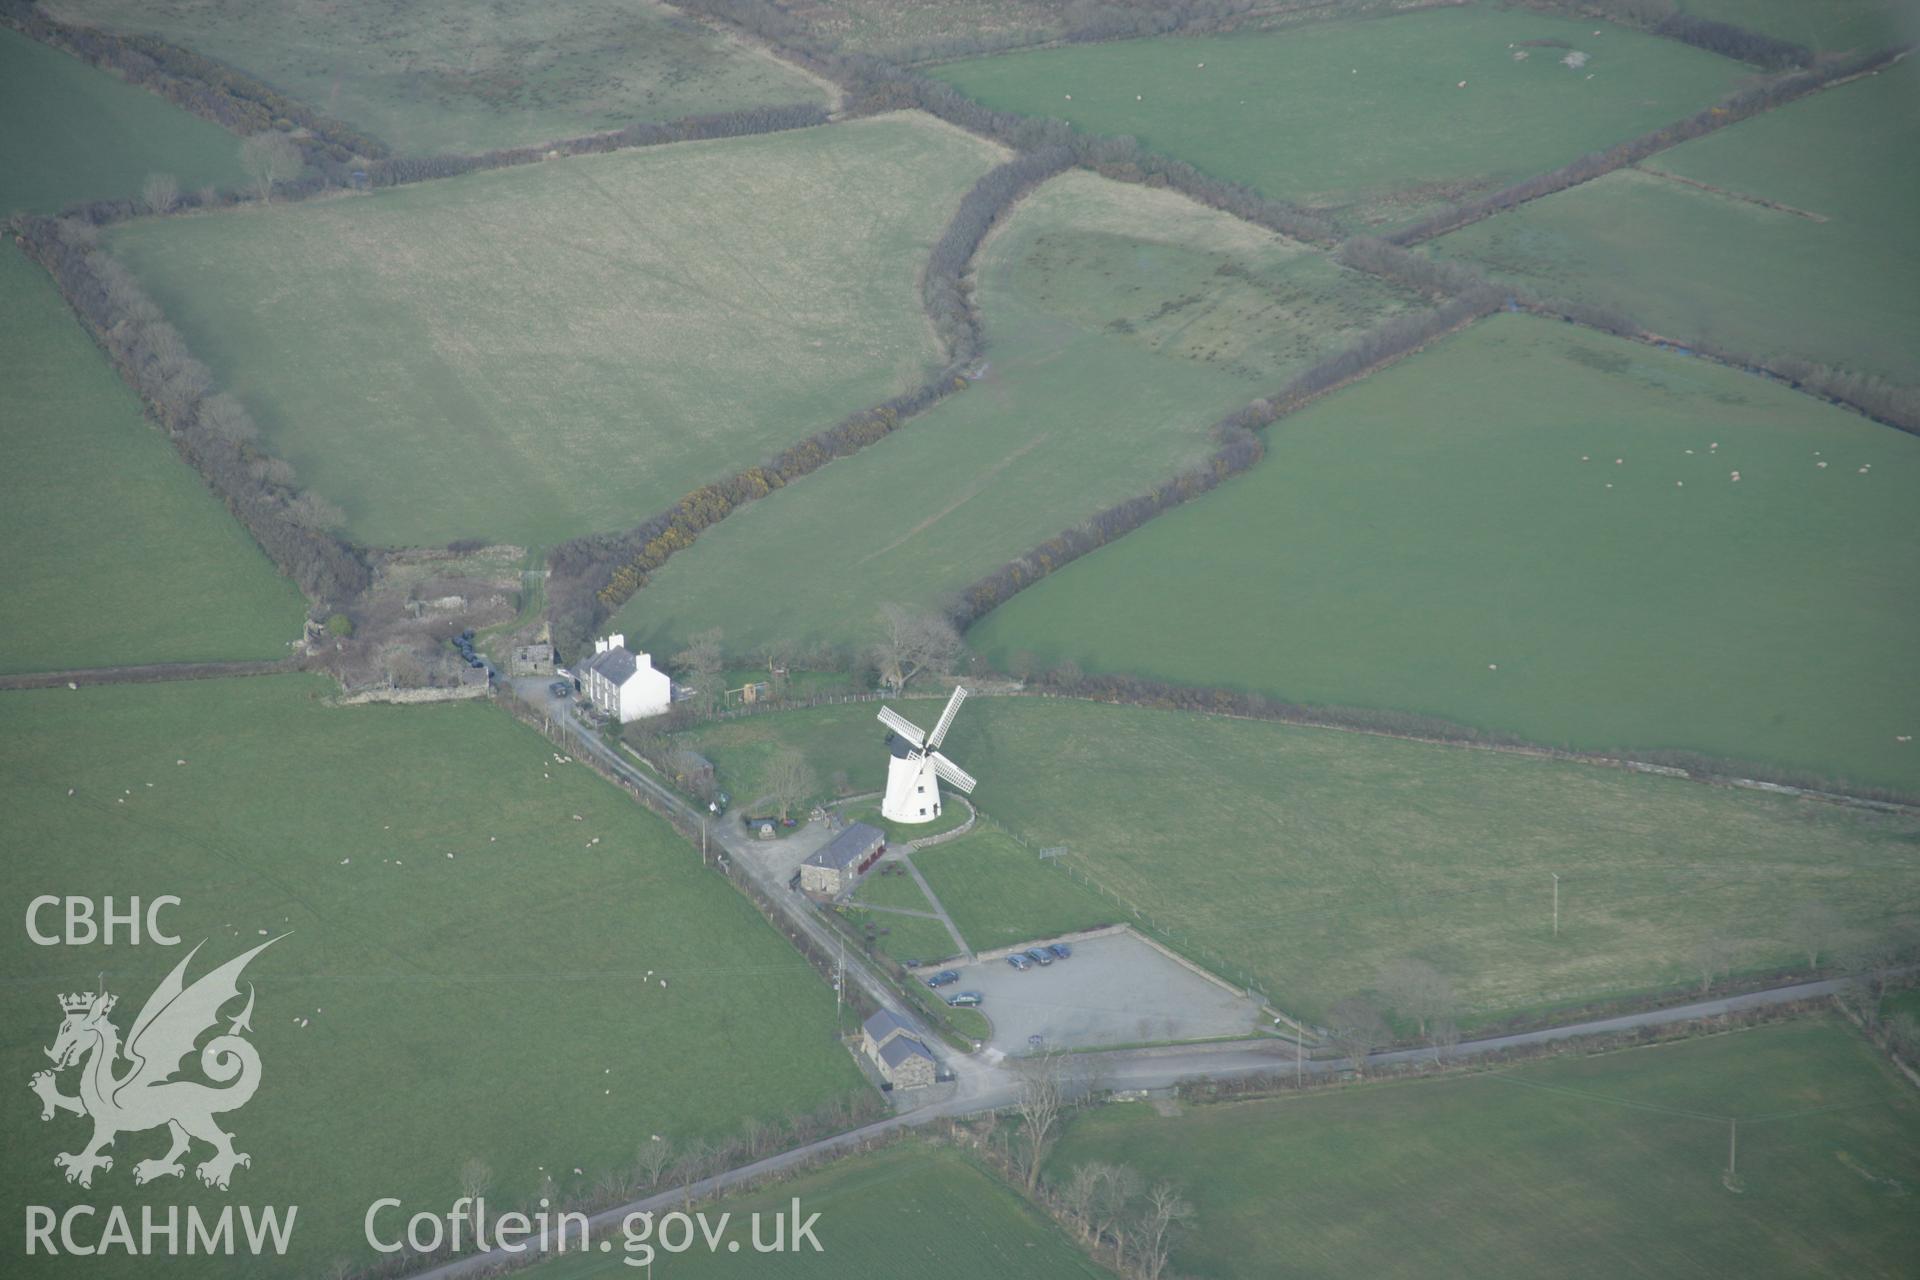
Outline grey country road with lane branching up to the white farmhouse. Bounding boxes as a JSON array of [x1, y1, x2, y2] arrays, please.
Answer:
[[405, 679, 1873, 1280]]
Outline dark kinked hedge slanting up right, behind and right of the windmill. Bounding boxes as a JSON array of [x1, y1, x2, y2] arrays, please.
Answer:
[[947, 288, 1503, 631]]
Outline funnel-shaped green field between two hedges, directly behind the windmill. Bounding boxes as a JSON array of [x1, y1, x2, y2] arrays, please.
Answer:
[[616, 173, 1404, 652]]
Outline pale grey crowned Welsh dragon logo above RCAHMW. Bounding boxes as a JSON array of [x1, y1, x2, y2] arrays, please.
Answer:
[[31, 935, 286, 1192]]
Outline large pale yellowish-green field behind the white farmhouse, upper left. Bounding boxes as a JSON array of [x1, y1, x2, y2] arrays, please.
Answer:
[[111, 115, 998, 547]]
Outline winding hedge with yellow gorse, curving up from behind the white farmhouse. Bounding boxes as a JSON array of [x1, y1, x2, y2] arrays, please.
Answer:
[[547, 148, 1073, 651]]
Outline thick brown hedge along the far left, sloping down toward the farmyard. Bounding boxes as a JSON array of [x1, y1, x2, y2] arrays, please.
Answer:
[[12, 217, 372, 614]]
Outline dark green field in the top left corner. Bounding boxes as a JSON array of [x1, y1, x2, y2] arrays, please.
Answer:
[[0, 25, 244, 217]]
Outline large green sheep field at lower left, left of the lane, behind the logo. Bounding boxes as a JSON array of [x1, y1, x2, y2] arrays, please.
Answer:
[[0, 677, 862, 1278]]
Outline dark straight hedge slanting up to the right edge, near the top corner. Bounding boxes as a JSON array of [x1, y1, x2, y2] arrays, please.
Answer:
[[1388, 50, 1903, 246]]
